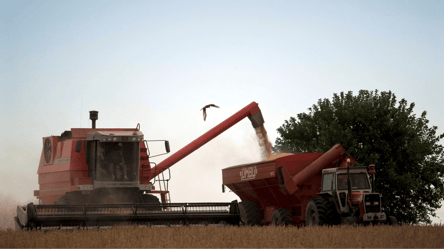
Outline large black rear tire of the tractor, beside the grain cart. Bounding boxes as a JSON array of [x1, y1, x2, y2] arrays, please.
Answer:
[[305, 197, 340, 226]]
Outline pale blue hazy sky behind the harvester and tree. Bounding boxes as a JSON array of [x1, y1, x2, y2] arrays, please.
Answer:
[[0, 1, 444, 226]]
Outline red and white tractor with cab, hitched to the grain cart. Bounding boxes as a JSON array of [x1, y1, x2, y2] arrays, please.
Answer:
[[305, 159, 397, 226]]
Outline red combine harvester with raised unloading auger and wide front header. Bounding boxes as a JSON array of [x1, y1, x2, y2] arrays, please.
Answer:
[[14, 102, 264, 230]]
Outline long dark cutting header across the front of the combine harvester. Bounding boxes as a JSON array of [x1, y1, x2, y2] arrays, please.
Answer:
[[16, 202, 240, 229]]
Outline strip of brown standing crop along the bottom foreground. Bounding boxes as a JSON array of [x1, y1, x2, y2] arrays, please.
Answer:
[[0, 226, 444, 249]]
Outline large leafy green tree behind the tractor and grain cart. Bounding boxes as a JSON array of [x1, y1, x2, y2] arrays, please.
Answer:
[[275, 90, 444, 223]]
